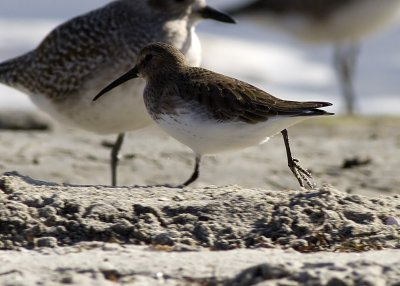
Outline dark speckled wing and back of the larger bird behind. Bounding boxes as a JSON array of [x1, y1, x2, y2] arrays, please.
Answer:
[[0, 1, 148, 97]]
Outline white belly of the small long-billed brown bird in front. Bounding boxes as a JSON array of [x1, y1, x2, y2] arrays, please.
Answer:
[[157, 113, 307, 155]]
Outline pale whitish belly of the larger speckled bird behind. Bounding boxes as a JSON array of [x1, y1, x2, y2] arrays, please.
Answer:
[[30, 79, 153, 134]]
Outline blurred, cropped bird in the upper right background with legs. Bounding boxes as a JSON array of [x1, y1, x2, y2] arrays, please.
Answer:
[[229, 0, 400, 114]]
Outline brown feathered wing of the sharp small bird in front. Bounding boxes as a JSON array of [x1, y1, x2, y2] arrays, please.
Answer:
[[178, 68, 331, 123]]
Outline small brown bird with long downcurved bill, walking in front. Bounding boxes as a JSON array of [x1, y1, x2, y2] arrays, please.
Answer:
[[93, 43, 332, 187]]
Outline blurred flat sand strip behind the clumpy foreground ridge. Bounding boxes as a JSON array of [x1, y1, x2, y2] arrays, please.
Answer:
[[0, 112, 400, 196]]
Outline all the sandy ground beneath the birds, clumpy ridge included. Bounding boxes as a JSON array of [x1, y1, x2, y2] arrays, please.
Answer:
[[0, 112, 400, 285]]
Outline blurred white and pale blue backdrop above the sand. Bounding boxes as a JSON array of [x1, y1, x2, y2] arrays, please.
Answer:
[[0, 0, 400, 115]]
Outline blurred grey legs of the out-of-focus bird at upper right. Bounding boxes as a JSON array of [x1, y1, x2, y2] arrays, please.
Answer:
[[334, 42, 360, 115]]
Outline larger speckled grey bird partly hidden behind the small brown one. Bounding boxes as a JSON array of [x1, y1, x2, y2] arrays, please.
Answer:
[[0, 0, 235, 185]]
